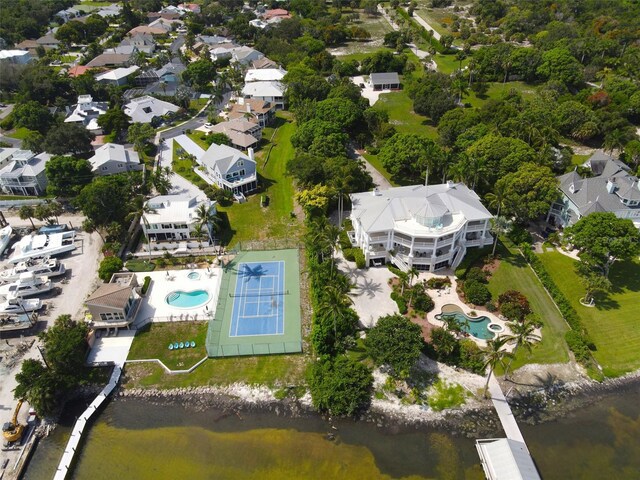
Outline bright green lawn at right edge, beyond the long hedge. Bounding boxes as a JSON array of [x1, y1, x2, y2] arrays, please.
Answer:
[[540, 252, 640, 377]]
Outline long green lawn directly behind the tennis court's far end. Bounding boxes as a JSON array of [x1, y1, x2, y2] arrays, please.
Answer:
[[219, 116, 301, 247]]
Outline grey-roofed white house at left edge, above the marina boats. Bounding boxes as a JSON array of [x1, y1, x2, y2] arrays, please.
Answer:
[[0, 149, 51, 196]]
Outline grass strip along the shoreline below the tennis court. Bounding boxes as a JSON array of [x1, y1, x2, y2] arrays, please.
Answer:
[[125, 352, 309, 389]]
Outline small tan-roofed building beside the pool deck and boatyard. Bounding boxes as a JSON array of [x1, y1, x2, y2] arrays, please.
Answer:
[[84, 272, 141, 332]]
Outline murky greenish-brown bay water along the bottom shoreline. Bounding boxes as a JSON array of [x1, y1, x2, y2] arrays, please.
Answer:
[[25, 386, 640, 480]]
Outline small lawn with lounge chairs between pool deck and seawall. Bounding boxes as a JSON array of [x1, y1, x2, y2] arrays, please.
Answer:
[[128, 322, 207, 370]]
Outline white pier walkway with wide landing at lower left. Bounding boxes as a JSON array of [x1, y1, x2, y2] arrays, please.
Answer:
[[53, 330, 136, 480]]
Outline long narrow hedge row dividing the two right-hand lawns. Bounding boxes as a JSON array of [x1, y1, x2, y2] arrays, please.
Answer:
[[520, 243, 596, 365]]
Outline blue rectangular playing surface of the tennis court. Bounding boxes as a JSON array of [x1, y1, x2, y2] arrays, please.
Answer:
[[229, 261, 287, 337]]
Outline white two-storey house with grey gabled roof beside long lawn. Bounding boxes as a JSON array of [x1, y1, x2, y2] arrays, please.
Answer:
[[196, 143, 258, 195]]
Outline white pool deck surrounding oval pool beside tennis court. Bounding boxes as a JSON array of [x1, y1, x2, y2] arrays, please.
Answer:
[[136, 267, 222, 321]]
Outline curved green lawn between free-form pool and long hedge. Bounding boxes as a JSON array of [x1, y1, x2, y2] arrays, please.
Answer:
[[489, 240, 569, 369]]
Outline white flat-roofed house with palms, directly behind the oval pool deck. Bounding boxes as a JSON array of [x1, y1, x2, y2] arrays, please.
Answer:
[[140, 194, 216, 242]]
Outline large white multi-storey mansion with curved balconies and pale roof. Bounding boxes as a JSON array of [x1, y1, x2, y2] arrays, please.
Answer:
[[349, 182, 493, 271]]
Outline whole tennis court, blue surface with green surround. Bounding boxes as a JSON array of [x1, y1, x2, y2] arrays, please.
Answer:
[[207, 249, 302, 357]]
